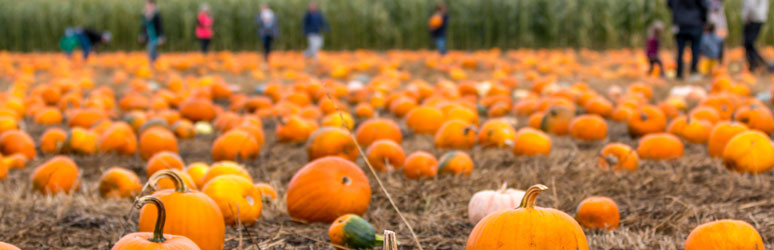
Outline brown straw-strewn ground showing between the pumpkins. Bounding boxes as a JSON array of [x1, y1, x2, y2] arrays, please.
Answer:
[[0, 49, 774, 249]]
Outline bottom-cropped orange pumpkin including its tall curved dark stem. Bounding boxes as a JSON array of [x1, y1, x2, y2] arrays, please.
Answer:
[[112, 196, 202, 250]]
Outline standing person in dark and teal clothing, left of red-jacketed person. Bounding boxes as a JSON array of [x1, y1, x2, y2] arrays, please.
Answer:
[[140, 0, 164, 62]]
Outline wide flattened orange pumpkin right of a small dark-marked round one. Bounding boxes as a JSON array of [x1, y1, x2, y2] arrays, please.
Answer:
[[637, 133, 683, 160]]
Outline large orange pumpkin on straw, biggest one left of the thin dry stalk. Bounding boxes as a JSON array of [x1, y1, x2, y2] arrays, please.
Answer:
[[285, 156, 371, 223]]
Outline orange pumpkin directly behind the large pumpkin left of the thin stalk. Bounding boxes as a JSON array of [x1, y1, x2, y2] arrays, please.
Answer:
[[306, 127, 359, 162]]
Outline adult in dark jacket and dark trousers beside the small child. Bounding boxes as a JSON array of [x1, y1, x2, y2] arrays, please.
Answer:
[[667, 0, 708, 78]]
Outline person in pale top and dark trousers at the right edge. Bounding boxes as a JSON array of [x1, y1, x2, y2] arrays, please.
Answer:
[[742, 0, 774, 72]]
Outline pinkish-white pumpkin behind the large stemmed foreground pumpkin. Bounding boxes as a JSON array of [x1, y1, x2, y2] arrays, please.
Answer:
[[468, 183, 524, 225]]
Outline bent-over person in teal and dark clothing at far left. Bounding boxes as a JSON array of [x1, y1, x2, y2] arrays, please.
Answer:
[[59, 28, 111, 59]]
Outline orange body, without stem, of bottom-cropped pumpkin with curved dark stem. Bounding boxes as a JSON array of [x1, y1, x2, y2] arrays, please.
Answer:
[[112, 232, 202, 250]]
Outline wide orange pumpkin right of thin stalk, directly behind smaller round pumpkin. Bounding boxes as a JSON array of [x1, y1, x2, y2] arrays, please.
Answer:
[[355, 118, 403, 147]]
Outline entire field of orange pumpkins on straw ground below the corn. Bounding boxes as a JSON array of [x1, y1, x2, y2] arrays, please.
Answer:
[[0, 49, 774, 249]]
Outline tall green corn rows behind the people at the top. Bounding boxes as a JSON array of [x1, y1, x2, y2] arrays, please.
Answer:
[[0, 0, 774, 51]]
